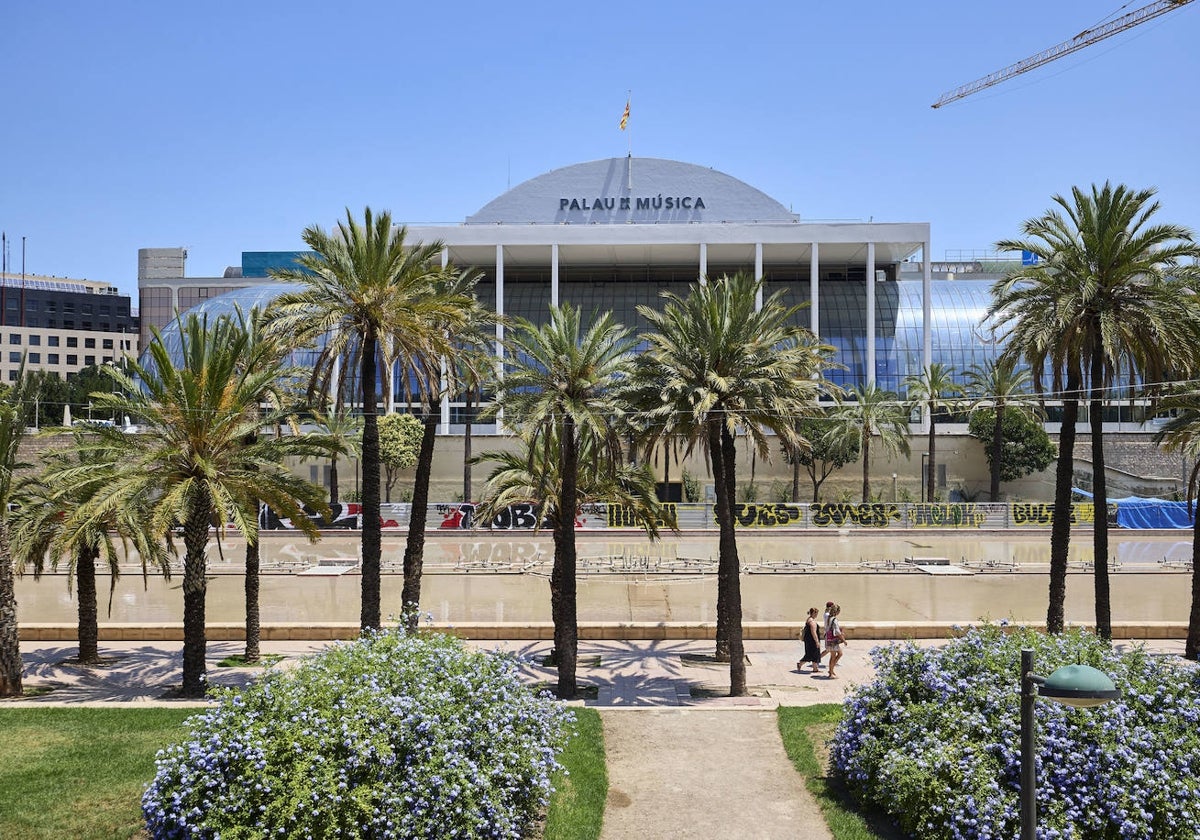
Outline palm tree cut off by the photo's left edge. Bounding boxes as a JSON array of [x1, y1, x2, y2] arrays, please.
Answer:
[[0, 366, 29, 697]]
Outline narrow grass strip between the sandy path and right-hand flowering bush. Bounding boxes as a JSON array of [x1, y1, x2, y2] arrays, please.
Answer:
[[779, 703, 904, 840]]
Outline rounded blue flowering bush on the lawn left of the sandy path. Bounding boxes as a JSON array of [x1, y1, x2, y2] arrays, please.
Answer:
[[142, 630, 571, 840]]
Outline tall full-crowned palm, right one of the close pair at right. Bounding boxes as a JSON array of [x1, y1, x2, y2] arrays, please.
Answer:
[[994, 182, 1200, 638]]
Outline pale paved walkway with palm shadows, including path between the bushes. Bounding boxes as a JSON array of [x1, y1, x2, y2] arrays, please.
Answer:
[[11, 640, 1183, 840]]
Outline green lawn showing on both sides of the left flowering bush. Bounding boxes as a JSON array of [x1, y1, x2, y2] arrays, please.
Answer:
[[0, 708, 608, 840]]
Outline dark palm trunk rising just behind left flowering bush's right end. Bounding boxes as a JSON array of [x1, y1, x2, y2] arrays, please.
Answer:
[[550, 416, 580, 700]]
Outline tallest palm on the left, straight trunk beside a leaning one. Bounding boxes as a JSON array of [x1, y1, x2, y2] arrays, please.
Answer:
[[270, 208, 463, 630]]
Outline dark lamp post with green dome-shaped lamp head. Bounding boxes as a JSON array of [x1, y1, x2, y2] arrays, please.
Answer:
[[1021, 648, 1121, 840]]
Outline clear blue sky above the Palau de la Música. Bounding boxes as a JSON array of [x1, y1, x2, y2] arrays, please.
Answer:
[[0, 0, 1200, 295]]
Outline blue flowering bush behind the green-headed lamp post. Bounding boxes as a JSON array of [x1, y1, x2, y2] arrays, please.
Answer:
[[830, 626, 1200, 840]]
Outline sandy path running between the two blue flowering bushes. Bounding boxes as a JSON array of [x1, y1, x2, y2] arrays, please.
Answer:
[[600, 708, 832, 840]]
